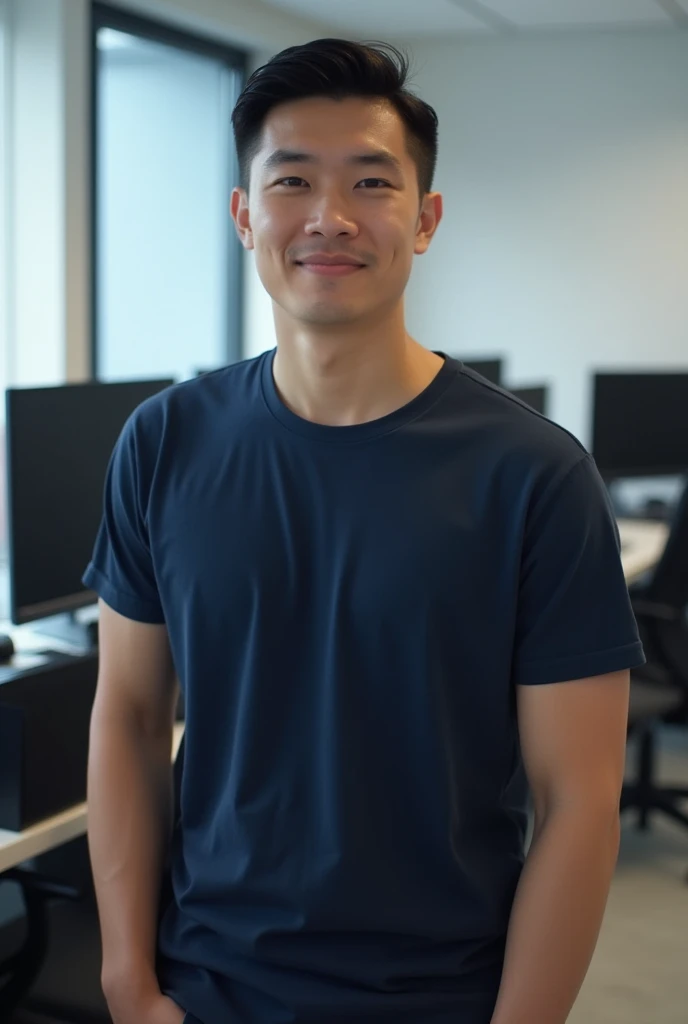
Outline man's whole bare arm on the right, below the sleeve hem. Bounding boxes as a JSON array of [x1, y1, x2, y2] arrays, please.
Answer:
[[492, 672, 629, 1024]]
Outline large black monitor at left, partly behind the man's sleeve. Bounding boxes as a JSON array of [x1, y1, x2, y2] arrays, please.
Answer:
[[6, 380, 174, 625]]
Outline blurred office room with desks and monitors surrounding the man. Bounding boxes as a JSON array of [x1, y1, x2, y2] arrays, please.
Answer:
[[0, 0, 688, 1024]]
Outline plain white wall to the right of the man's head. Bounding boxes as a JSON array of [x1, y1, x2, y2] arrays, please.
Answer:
[[407, 32, 688, 442]]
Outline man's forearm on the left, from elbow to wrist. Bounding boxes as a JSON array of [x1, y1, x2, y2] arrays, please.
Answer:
[[88, 706, 172, 990]]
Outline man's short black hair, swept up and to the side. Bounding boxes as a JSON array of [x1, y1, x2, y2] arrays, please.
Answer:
[[231, 39, 437, 196]]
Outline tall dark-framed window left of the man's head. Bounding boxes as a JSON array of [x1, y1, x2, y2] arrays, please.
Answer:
[[93, 5, 245, 380]]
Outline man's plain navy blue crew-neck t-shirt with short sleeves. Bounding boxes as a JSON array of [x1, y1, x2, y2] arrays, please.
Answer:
[[84, 351, 643, 1024]]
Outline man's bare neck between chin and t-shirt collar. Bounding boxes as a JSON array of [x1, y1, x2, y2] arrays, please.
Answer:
[[273, 307, 442, 426]]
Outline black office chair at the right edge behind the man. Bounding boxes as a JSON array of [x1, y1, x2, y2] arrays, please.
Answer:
[[621, 482, 688, 843]]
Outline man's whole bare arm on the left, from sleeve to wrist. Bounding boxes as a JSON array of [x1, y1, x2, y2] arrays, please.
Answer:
[[88, 601, 177, 1020]]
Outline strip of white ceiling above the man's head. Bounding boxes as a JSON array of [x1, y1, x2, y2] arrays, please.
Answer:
[[256, 0, 688, 38]]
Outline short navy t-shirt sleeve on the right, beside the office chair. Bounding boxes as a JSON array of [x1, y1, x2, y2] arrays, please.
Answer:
[[513, 455, 645, 684]]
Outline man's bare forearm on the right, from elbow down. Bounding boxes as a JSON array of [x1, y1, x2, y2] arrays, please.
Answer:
[[491, 810, 619, 1024]]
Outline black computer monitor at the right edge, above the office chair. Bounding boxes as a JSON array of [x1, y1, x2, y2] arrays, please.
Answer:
[[592, 371, 688, 480]]
